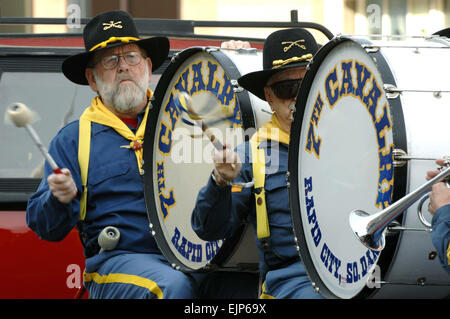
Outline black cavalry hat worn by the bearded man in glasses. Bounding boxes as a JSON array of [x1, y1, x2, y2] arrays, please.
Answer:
[[62, 11, 169, 85]]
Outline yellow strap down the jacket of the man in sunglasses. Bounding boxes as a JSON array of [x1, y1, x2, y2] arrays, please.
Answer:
[[250, 134, 270, 239]]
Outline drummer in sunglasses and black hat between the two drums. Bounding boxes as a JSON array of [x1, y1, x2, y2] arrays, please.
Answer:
[[191, 28, 321, 299]]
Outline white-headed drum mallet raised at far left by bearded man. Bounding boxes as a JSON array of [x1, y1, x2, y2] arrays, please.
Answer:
[[6, 102, 62, 174]]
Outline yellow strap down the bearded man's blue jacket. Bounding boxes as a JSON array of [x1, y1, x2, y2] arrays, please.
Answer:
[[78, 117, 91, 220]]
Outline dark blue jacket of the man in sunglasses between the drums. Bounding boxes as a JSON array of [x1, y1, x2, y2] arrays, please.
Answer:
[[191, 141, 298, 276]]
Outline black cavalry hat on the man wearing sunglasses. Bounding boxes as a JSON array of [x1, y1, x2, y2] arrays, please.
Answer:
[[238, 28, 318, 100]]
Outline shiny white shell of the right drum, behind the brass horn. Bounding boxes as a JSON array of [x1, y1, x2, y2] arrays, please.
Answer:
[[375, 39, 450, 298]]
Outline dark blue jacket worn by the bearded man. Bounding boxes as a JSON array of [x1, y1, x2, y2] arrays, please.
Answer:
[[27, 112, 159, 272]]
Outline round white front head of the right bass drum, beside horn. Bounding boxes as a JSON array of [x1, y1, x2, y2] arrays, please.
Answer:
[[289, 38, 394, 298]]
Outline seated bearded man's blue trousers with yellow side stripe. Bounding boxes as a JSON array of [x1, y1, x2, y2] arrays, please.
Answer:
[[84, 253, 259, 299]]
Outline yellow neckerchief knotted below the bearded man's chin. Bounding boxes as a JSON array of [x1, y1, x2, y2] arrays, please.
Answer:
[[81, 89, 153, 172]]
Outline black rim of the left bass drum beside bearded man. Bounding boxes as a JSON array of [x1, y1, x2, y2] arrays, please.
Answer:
[[143, 47, 256, 272]]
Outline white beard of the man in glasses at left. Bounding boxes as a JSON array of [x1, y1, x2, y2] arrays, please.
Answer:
[[94, 66, 149, 113]]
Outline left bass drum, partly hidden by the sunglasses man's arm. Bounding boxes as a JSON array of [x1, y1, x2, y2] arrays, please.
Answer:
[[144, 47, 270, 272]]
